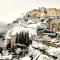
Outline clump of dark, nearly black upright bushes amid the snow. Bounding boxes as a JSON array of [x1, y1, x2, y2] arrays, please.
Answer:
[[16, 31, 32, 47]]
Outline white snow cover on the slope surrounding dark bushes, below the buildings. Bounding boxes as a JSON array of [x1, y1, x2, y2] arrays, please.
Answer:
[[0, 18, 60, 60]]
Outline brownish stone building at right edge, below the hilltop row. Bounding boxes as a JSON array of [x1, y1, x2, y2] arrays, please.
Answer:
[[47, 19, 60, 32]]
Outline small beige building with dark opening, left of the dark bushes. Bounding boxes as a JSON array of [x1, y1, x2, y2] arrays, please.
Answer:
[[4, 35, 16, 48]]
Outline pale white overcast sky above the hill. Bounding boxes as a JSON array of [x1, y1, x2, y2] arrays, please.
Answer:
[[0, 0, 60, 23]]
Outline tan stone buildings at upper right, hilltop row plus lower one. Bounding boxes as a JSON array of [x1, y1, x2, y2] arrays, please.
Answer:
[[26, 7, 60, 33]]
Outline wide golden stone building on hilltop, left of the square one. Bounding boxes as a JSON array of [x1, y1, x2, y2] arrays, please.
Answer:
[[26, 8, 45, 17]]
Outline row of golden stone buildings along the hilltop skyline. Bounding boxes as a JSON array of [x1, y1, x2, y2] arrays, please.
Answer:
[[26, 7, 60, 17]]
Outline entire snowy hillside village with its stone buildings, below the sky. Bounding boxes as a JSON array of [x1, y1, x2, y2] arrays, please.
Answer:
[[0, 7, 60, 60]]
